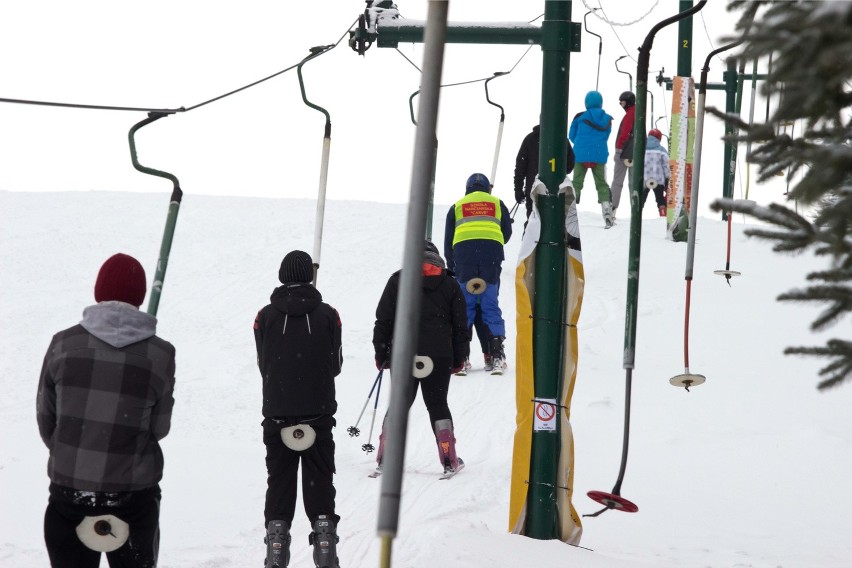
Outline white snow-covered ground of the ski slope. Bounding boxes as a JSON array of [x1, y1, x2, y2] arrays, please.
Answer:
[[0, 192, 852, 568]]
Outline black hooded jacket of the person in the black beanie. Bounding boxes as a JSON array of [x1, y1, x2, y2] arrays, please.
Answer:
[[254, 283, 343, 418]]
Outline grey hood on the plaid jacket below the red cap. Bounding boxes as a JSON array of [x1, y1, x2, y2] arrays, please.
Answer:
[[80, 302, 157, 347]]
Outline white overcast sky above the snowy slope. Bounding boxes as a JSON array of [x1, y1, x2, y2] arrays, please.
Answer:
[[0, 0, 764, 213]]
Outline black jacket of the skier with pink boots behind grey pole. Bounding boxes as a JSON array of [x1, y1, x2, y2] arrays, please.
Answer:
[[373, 265, 470, 367]]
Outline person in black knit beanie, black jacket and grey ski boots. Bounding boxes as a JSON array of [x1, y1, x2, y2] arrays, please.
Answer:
[[254, 250, 343, 568]]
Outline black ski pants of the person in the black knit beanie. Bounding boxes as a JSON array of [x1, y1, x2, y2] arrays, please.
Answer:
[[263, 415, 340, 525]]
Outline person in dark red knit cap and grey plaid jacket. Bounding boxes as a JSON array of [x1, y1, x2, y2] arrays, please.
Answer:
[[36, 253, 175, 568]]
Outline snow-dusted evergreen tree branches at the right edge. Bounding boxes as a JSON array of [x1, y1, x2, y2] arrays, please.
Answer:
[[708, 0, 852, 389]]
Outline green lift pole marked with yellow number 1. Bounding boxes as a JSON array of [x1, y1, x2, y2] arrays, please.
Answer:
[[525, 1, 579, 539]]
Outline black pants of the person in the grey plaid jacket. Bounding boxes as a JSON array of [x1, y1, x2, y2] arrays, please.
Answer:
[[44, 483, 160, 568]]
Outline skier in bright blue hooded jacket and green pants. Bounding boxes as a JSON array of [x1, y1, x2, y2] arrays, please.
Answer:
[[568, 91, 612, 229]]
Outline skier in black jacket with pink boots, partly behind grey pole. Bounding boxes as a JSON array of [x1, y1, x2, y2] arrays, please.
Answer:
[[373, 241, 470, 472]]
